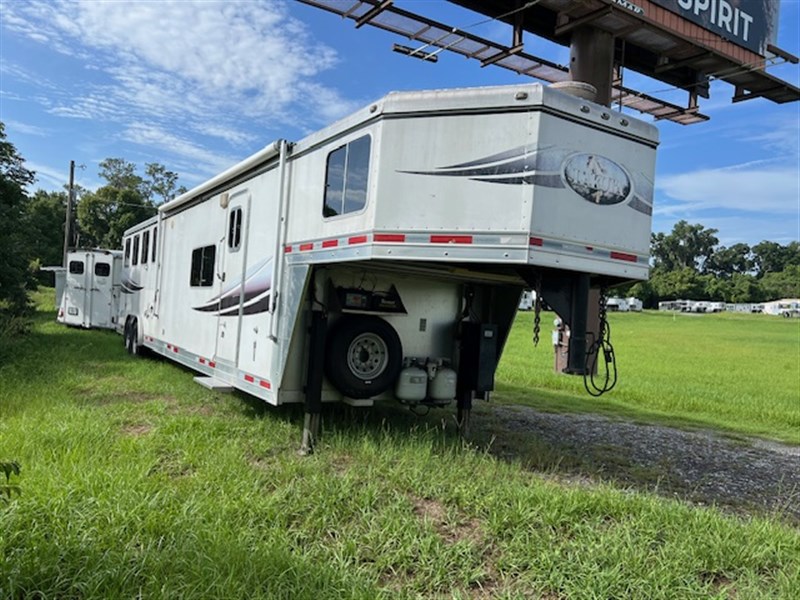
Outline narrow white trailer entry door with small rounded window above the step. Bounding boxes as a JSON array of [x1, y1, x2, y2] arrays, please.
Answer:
[[215, 189, 250, 366]]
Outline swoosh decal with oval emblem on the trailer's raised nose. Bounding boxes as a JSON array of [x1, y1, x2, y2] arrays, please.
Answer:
[[398, 146, 653, 215]]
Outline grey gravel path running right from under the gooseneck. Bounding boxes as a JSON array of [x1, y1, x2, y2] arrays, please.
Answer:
[[482, 406, 800, 523]]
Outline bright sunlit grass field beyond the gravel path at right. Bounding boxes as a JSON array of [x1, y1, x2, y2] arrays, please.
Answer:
[[494, 311, 800, 444]]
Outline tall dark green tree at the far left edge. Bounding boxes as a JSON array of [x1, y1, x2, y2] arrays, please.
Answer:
[[0, 122, 35, 314]]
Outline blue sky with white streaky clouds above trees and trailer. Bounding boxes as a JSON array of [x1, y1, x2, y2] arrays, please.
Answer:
[[0, 0, 800, 245]]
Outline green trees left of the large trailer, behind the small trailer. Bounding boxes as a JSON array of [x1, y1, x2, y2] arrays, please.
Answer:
[[0, 122, 186, 320]]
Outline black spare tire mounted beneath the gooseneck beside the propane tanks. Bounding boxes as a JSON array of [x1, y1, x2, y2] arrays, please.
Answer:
[[325, 315, 403, 400]]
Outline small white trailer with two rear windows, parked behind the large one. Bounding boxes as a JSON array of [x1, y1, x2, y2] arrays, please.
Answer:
[[57, 250, 122, 329]]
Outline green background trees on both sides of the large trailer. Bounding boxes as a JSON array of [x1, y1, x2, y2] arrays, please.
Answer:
[[0, 122, 800, 317]]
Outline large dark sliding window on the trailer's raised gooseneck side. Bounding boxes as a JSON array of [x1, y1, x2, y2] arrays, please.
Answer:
[[322, 135, 371, 217]]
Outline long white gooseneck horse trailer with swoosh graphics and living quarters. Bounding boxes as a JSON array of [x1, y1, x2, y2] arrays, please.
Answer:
[[119, 84, 657, 450]]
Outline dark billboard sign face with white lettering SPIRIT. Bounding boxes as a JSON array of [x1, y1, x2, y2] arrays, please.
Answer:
[[650, 0, 780, 56]]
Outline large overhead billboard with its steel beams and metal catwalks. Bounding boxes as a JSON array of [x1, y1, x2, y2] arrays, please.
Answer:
[[300, 0, 800, 125]]
